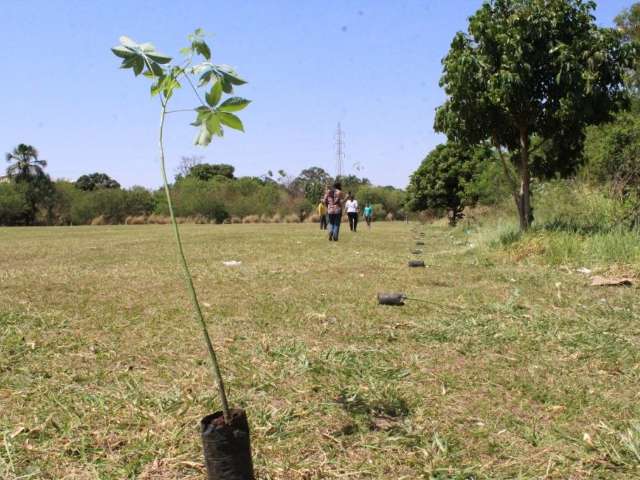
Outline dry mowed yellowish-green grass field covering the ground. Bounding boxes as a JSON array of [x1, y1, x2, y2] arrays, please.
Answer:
[[0, 222, 640, 480]]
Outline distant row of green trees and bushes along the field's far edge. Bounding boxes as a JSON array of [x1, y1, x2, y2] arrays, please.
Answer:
[[0, 155, 405, 225]]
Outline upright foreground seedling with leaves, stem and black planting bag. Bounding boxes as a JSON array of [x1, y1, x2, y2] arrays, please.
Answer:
[[111, 29, 254, 480]]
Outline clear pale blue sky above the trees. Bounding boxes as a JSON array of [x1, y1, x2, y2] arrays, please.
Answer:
[[0, 0, 632, 188]]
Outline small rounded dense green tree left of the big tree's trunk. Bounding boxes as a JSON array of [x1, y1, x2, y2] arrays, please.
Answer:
[[408, 143, 492, 226]]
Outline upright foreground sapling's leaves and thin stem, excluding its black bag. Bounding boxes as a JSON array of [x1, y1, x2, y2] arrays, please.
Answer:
[[111, 29, 249, 424]]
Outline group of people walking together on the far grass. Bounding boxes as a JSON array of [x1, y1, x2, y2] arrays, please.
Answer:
[[317, 182, 373, 242]]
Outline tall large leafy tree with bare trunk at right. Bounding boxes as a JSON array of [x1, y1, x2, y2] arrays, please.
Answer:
[[435, 0, 634, 230]]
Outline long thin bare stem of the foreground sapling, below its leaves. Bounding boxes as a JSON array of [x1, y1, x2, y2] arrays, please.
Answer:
[[158, 100, 231, 424]]
